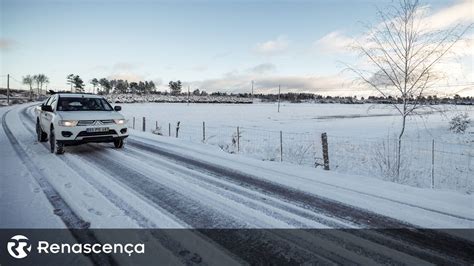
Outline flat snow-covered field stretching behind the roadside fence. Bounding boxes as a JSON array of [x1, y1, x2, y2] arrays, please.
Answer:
[[122, 103, 474, 193]]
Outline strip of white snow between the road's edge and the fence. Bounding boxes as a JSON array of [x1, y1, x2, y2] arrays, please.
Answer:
[[131, 131, 474, 228]]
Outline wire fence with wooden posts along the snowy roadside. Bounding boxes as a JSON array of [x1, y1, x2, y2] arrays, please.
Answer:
[[129, 117, 474, 193]]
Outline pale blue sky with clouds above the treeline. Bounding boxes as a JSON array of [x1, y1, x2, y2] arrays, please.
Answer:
[[0, 0, 474, 95]]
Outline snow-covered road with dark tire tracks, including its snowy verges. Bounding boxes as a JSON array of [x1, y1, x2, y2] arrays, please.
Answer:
[[0, 102, 474, 263]]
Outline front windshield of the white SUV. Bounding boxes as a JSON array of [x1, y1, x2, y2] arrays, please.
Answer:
[[56, 97, 112, 111]]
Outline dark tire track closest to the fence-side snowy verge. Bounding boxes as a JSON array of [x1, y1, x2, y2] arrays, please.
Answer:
[[128, 140, 472, 263]]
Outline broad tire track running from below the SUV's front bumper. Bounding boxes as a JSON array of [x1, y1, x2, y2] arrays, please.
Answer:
[[72, 148, 350, 264]]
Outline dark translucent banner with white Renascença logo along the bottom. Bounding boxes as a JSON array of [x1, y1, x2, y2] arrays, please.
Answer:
[[0, 229, 474, 265]]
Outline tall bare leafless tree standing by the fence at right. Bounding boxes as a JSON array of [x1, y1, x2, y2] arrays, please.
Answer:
[[348, 0, 471, 175]]
